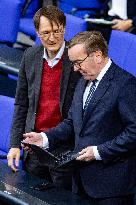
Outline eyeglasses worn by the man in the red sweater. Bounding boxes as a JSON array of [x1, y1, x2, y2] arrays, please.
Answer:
[[38, 29, 64, 38]]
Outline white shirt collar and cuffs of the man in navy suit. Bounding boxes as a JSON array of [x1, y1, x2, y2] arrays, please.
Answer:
[[41, 59, 112, 160]]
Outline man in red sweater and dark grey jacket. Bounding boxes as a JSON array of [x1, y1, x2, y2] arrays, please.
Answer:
[[8, 6, 80, 190]]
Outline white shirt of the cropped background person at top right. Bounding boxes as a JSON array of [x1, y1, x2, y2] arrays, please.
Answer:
[[108, 0, 128, 20]]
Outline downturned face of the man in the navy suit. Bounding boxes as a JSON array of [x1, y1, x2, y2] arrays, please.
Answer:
[[68, 44, 102, 81]]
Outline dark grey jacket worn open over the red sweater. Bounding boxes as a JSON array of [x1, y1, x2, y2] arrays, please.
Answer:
[[11, 46, 80, 147]]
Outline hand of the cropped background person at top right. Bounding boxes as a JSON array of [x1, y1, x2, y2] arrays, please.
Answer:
[[112, 19, 132, 31]]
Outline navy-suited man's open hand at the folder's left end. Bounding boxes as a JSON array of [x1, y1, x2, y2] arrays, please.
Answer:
[[23, 132, 43, 147]]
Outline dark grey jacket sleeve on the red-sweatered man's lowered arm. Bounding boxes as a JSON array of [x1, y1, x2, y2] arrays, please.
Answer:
[[10, 49, 29, 148]]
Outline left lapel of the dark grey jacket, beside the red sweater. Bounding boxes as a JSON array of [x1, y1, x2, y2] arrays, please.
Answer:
[[34, 46, 44, 111]]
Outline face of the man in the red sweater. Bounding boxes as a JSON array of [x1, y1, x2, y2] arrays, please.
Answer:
[[37, 16, 65, 57]]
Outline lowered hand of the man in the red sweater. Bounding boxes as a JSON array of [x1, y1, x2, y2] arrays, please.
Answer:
[[7, 148, 20, 172]]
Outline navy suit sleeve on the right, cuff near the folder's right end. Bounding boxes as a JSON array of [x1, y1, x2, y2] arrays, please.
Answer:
[[97, 78, 136, 162]]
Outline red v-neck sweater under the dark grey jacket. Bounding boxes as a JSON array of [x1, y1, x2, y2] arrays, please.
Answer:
[[35, 60, 62, 132]]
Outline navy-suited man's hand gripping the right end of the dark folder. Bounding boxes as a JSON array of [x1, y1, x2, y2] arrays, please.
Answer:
[[76, 146, 95, 162]]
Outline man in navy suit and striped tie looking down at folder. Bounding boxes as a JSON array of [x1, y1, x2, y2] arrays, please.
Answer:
[[24, 31, 136, 205]]
